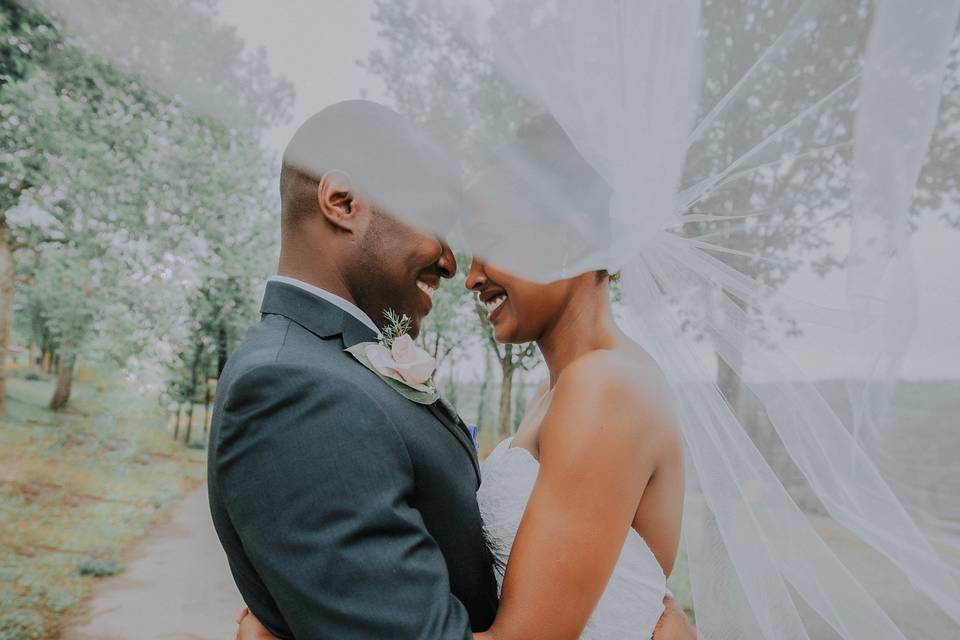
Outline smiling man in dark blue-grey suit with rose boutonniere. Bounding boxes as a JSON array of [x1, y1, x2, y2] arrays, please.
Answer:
[[208, 101, 682, 640]]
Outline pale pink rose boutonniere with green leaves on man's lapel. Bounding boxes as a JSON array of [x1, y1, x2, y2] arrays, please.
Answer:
[[347, 309, 439, 404]]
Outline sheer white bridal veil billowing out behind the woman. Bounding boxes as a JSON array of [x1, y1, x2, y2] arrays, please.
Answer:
[[37, 0, 960, 640]]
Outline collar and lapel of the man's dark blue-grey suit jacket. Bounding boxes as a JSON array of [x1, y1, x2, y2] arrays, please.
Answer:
[[260, 282, 480, 483]]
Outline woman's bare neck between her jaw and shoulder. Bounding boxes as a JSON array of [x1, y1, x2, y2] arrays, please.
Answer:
[[537, 282, 620, 389]]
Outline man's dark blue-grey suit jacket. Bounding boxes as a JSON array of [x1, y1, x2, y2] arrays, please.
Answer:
[[208, 282, 497, 640]]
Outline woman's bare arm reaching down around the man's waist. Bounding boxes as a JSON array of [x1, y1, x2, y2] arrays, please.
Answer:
[[475, 353, 678, 640]]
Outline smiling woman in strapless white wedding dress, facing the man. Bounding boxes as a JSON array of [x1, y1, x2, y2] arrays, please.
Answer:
[[466, 117, 684, 640]]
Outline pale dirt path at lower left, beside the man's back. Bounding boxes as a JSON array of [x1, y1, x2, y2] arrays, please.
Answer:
[[61, 486, 241, 640]]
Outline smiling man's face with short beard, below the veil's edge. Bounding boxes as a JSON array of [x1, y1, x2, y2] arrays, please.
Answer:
[[353, 211, 457, 337]]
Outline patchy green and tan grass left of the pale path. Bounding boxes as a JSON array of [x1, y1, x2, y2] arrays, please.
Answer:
[[0, 373, 204, 640]]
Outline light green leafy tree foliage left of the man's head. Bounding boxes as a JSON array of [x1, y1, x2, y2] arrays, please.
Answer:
[[0, 2, 289, 406]]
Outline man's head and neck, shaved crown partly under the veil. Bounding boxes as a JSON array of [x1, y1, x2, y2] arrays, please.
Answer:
[[280, 100, 460, 332]]
